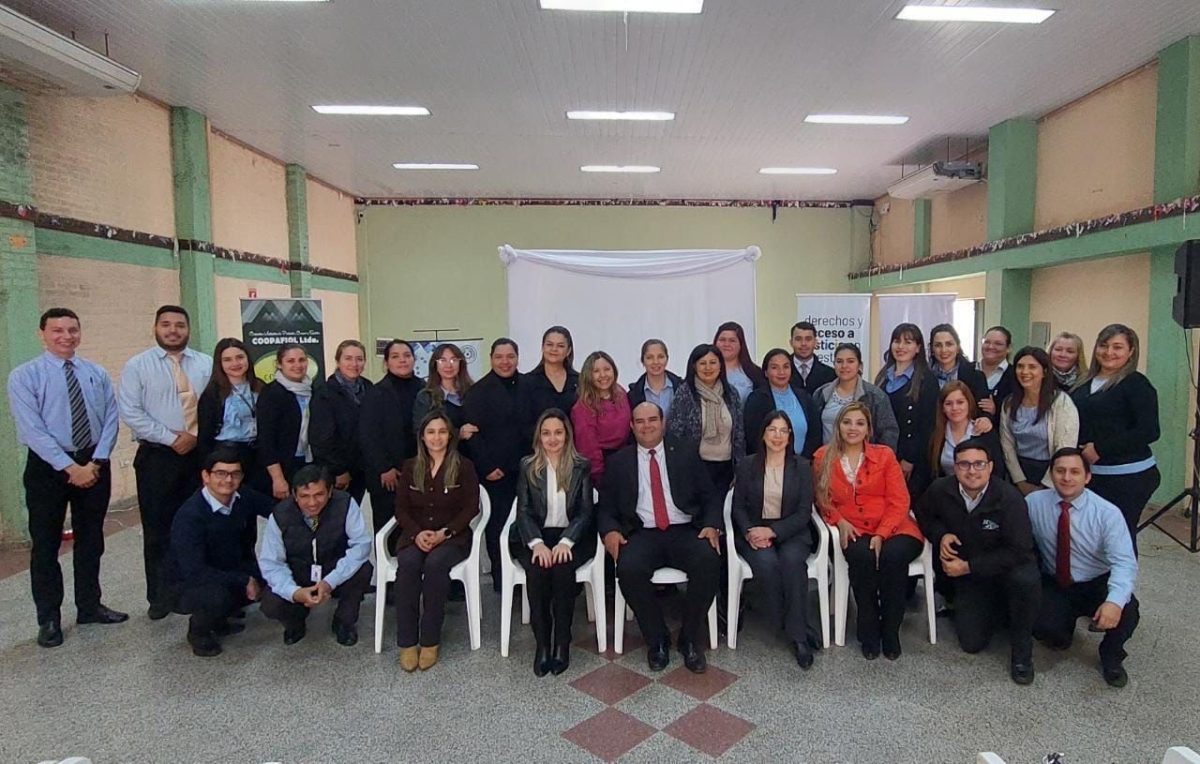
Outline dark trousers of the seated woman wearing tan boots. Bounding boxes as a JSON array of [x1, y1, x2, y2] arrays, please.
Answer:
[[392, 543, 468, 648]]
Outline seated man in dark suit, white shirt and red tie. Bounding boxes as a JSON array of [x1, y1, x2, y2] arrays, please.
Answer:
[[598, 403, 724, 674]]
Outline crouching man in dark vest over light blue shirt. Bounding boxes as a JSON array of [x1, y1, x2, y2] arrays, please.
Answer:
[[258, 464, 372, 646]]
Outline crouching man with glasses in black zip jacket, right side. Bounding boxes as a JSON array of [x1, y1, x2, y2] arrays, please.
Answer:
[[916, 439, 1042, 685]]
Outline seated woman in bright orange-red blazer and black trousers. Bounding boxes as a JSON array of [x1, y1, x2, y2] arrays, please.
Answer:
[[812, 402, 925, 661]]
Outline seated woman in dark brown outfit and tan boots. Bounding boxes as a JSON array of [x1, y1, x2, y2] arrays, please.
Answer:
[[393, 409, 479, 672]]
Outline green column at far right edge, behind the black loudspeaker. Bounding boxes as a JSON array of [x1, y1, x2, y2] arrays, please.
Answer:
[[1145, 36, 1200, 503]]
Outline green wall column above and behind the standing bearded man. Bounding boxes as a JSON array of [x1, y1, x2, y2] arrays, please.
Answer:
[[170, 107, 217, 353]]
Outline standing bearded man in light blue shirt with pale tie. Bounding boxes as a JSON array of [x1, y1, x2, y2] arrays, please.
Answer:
[[118, 305, 212, 620]]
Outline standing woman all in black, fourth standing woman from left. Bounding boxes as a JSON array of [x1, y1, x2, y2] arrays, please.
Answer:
[[359, 339, 422, 531]]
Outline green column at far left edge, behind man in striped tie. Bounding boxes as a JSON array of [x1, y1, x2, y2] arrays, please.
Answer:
[[0, 83, 42, 545]]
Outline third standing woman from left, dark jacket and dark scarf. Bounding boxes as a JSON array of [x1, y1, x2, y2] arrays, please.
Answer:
[[308, 339, 373, 504]]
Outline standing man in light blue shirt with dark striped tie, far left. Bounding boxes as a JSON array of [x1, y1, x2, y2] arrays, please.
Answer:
[[8, 308, 128, 648]]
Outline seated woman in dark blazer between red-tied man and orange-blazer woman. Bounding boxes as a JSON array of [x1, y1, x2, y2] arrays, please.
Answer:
[[732, 410, 824, 670]]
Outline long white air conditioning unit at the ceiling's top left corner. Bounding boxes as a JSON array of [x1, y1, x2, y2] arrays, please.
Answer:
[[0, 5, 142, 96]]
